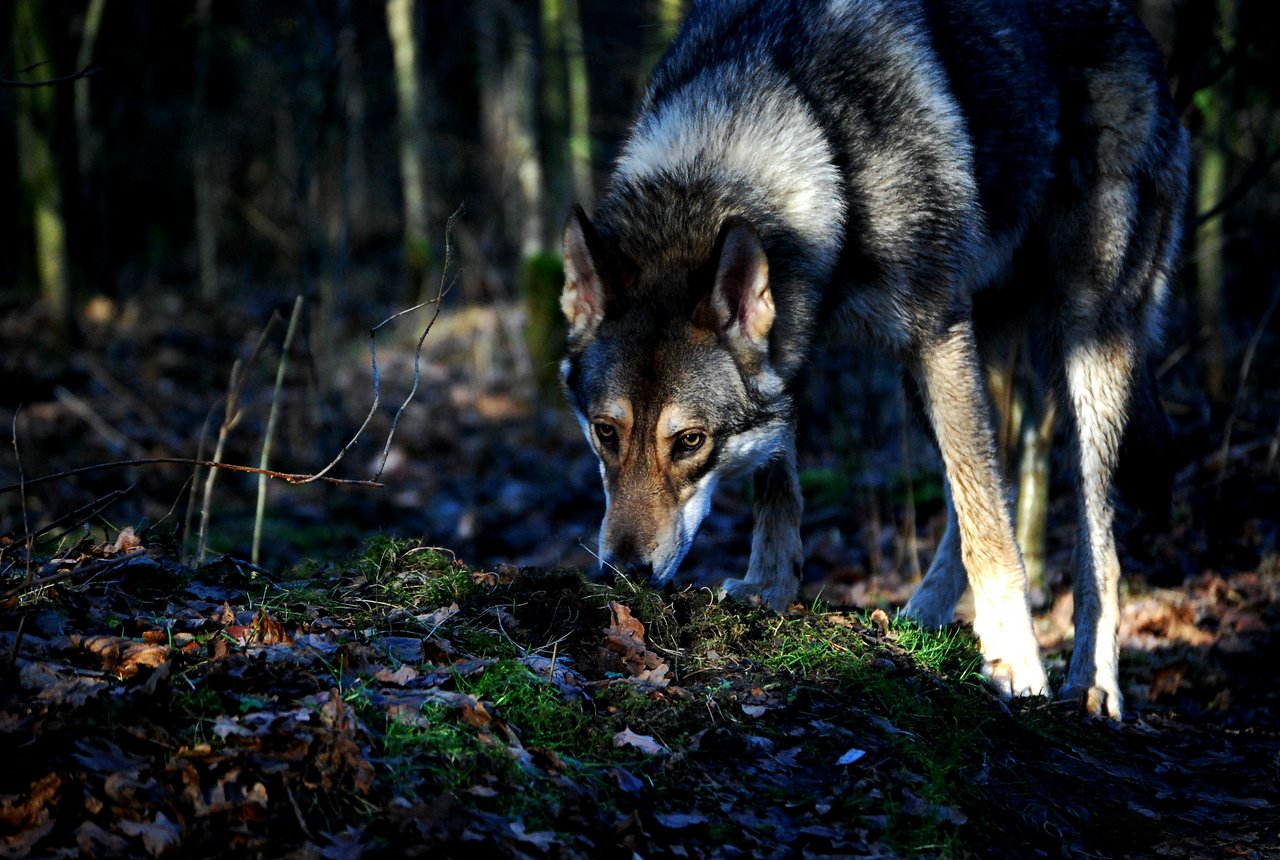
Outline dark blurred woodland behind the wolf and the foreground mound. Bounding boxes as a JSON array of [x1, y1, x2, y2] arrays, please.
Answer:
[[0, 0, 1280, 599]]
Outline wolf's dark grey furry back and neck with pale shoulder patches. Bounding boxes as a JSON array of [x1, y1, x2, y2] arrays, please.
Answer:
[[599, 0, 1185, 358]]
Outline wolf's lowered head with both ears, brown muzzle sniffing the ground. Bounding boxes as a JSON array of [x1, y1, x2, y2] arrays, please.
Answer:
[[561, 209, 788, 584]]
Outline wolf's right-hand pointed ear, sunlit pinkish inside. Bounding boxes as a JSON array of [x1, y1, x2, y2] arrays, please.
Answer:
[[694, 219, 774, 352]]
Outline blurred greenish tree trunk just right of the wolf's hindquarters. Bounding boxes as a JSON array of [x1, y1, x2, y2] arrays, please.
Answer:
[[1196, 0, 1236, 403]]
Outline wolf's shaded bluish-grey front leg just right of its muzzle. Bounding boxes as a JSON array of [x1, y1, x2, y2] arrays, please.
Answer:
[[721, 431, 804, 612]]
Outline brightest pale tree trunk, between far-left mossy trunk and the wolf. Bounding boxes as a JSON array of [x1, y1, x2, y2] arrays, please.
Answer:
[[387, 0, 430, 289]]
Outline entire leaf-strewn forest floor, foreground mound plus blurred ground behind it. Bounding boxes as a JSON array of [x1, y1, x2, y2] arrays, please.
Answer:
[[0, 291, 1280, 857]]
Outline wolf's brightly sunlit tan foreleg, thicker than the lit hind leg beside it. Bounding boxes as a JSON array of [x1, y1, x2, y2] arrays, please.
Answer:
[[913, 320, 1048, 696]]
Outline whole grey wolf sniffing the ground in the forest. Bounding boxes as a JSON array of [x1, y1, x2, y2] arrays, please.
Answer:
[[561, 0, 1188, 719]]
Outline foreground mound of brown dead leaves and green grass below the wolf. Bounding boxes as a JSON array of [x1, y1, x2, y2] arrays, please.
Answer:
[[0, 532, 1280, 857]]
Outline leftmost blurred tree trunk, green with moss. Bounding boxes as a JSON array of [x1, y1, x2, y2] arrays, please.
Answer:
[[13, 0, 72, 334]]
